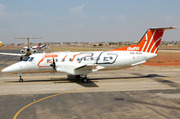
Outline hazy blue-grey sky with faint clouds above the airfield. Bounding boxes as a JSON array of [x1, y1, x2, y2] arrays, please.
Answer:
[[0, 0, 180, 44]]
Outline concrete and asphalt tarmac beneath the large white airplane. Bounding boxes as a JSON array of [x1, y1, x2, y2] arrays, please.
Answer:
[[0, 51, 180, 119]]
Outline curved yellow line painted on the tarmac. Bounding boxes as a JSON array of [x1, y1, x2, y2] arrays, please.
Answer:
[[13, 79, 150, 119]]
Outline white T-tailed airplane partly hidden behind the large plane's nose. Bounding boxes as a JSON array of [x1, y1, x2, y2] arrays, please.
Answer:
[[0, 37, 41, 61]]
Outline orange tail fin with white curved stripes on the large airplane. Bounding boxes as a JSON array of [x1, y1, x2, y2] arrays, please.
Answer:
[[111, 27, 176, 54]]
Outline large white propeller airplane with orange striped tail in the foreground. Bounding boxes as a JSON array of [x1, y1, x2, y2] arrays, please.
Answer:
[[1, 27, 176, 83]]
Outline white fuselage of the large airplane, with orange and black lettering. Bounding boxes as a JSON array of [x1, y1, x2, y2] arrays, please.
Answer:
[[3, 51, 157, 75]]
